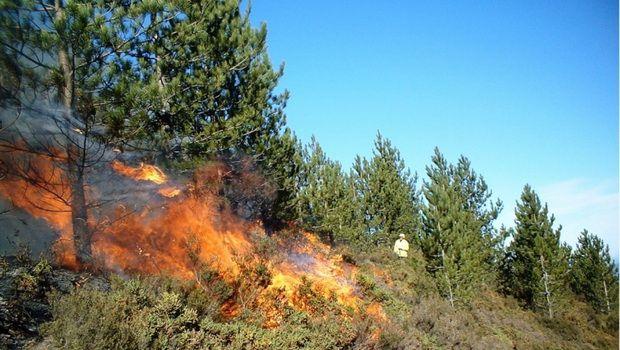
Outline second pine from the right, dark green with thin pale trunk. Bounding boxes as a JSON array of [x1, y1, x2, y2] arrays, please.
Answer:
[[505, 185, 570, 318]]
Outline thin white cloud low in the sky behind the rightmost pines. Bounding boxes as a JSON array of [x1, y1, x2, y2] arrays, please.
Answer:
[[498, 179, 619, 257]]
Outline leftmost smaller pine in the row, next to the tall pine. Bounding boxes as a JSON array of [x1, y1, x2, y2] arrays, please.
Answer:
[[299, 137, 359, 244]]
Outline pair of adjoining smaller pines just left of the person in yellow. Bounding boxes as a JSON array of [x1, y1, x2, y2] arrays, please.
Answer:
[[298, 134, 419, 246]]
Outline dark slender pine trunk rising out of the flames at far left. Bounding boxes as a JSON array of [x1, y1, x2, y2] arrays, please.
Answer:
[[54, 0, 92, 265]]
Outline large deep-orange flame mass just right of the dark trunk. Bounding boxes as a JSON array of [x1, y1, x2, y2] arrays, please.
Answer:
[[94, 197, 251, 279]]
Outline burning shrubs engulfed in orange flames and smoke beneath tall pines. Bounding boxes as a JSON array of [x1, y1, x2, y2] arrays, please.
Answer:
[[2, 153, 368, 328]]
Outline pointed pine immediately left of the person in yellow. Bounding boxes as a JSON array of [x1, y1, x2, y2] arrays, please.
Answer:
[[351, 133, 420, 244]]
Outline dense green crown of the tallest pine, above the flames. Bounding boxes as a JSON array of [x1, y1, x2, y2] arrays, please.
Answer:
[[108, 0, 288, 160]]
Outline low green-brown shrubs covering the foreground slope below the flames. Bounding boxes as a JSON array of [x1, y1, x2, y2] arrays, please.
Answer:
[[35, 244, 618, 349]]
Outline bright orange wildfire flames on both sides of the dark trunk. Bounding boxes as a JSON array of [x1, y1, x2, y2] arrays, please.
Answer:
[[0, 158, 359, 327]]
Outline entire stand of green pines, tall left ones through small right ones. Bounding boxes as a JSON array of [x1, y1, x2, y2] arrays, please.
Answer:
[[0, 0, 618, 348]]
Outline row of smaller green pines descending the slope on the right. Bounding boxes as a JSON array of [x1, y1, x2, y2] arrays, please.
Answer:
[[299, 135, 618, 318]]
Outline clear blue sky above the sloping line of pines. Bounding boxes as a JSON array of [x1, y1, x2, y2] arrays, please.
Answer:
[[252, 0, 618, 255]]
